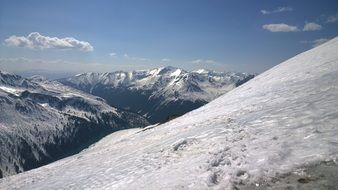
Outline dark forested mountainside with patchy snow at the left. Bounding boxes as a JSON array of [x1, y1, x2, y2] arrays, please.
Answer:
[[0, 71, 147, 177]]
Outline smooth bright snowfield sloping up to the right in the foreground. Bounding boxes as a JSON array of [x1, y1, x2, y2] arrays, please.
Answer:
[[0, 38, 338, 189]]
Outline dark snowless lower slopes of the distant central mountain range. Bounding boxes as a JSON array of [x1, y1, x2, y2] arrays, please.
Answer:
[[88, 86, 208, 123]]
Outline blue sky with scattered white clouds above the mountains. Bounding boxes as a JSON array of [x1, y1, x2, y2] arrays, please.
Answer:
[[0, 0, 338, 76]]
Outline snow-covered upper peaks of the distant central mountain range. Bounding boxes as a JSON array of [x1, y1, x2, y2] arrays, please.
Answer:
[[60, 66, 249, 95]]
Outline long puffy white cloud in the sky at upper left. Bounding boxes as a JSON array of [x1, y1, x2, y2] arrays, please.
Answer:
[[5, 32, 94, 52]]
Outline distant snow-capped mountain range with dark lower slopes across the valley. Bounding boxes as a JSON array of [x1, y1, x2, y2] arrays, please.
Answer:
[[59, 67, 254, 123]]
